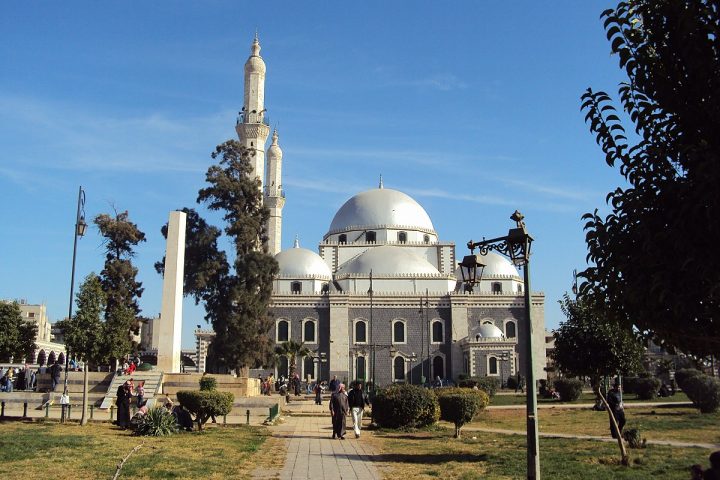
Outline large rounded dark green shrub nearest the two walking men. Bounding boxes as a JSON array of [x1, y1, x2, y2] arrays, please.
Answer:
[[372, 384, 440, 428]]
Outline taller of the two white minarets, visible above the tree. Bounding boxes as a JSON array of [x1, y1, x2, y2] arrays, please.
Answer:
[[235, 33, 270, 187]]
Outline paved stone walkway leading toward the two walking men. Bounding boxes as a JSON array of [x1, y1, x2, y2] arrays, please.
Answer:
[[254, 414, 383, 480]]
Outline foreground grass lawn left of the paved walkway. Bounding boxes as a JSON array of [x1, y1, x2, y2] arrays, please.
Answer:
[[0, 421, 276, 480]]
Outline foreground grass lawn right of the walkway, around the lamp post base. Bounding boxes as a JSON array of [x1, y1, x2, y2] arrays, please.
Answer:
[[373, 430, 710, 480]]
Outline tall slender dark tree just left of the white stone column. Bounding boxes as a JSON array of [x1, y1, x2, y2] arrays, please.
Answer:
[[94, 211, 145, 360]]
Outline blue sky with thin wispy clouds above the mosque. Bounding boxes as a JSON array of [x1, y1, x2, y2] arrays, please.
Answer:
[[0, 1, 622, 346]]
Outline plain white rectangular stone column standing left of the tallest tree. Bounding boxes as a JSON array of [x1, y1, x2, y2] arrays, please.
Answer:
[[157, 212, 187, 373]]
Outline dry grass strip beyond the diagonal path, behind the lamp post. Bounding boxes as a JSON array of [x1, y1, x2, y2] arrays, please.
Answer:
[[470, 405, 720, 444]]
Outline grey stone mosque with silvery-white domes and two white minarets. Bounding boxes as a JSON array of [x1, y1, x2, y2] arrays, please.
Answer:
[[196, 36, 546, 385]]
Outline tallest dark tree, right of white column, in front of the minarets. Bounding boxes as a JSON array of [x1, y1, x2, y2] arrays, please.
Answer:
[[156, 140, 278, 372]]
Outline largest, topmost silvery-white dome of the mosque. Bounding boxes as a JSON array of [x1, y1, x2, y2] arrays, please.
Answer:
[[328, 188, 435, 235]]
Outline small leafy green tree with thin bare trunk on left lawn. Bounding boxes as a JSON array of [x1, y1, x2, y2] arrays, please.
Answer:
[[57, 273, 106, 425]]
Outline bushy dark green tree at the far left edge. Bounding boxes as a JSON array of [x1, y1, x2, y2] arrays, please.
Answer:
[[0, 302, 37, 362]]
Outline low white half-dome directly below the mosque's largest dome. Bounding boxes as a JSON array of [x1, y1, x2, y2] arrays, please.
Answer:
[[337, 245, 440, 275]]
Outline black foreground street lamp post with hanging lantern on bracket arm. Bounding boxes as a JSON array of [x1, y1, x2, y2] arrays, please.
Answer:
[[460, 210, 540, 480]]
